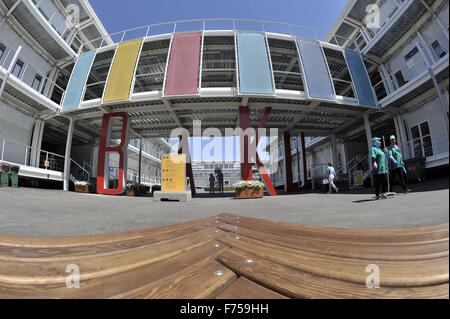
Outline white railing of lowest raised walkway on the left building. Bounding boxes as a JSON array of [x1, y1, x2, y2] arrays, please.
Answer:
[[0, 136, 64, 172]]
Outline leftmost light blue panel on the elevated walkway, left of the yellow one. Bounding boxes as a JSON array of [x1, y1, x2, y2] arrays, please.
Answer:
[[62, 51, 96, 110]]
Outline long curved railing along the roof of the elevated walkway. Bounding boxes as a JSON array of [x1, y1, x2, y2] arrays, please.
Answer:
[[80, 18, 348, 52]]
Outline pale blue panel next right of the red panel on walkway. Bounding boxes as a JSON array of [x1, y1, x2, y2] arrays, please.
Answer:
[[236, 32, 274, 94]]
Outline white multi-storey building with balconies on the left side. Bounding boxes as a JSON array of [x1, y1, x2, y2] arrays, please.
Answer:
[[0, 0, 170, 189]]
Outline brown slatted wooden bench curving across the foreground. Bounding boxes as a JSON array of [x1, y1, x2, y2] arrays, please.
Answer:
[[0, 214, 449, 299]]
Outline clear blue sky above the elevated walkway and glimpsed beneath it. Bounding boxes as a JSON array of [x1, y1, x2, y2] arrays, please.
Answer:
[[89, 0, 348, 161]]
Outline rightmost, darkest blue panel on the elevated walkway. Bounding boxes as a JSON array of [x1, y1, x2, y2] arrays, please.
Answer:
[[344, 49, 378, 107]]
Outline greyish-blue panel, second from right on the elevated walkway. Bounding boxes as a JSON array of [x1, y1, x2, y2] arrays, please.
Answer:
[[297, 38, 336, 100]]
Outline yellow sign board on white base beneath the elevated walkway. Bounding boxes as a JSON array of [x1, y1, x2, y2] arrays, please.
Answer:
[[161, 154, 186, 193]]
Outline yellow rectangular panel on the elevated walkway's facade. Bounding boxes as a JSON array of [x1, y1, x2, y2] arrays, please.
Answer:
[[103, 40, 142, 103]]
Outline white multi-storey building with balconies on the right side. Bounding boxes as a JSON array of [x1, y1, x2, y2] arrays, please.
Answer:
[[273, 0, 449, 190]]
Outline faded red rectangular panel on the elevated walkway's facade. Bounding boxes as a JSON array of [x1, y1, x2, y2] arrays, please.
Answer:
[[165, 32, 202, 95]]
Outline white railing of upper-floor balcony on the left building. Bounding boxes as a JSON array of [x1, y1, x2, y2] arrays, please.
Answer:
[[0, 39, 65, 104]]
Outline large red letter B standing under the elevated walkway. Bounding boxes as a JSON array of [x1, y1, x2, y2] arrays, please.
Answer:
[[97, 113, 128, 195]]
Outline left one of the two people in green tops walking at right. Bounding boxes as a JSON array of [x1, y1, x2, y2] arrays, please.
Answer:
[[370, 137, 388, 200]]
